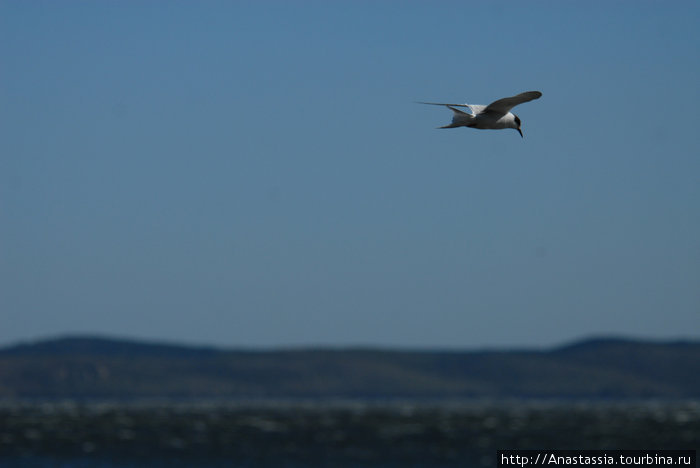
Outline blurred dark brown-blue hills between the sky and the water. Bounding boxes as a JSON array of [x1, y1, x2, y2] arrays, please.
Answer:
[[0, 337, 700, 399]]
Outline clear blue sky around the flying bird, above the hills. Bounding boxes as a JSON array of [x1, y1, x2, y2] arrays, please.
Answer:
[[0, 0, 700, 348]]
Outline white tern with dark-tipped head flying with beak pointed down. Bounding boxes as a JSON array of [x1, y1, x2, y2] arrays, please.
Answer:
[[419, 91, 542, 137]]
